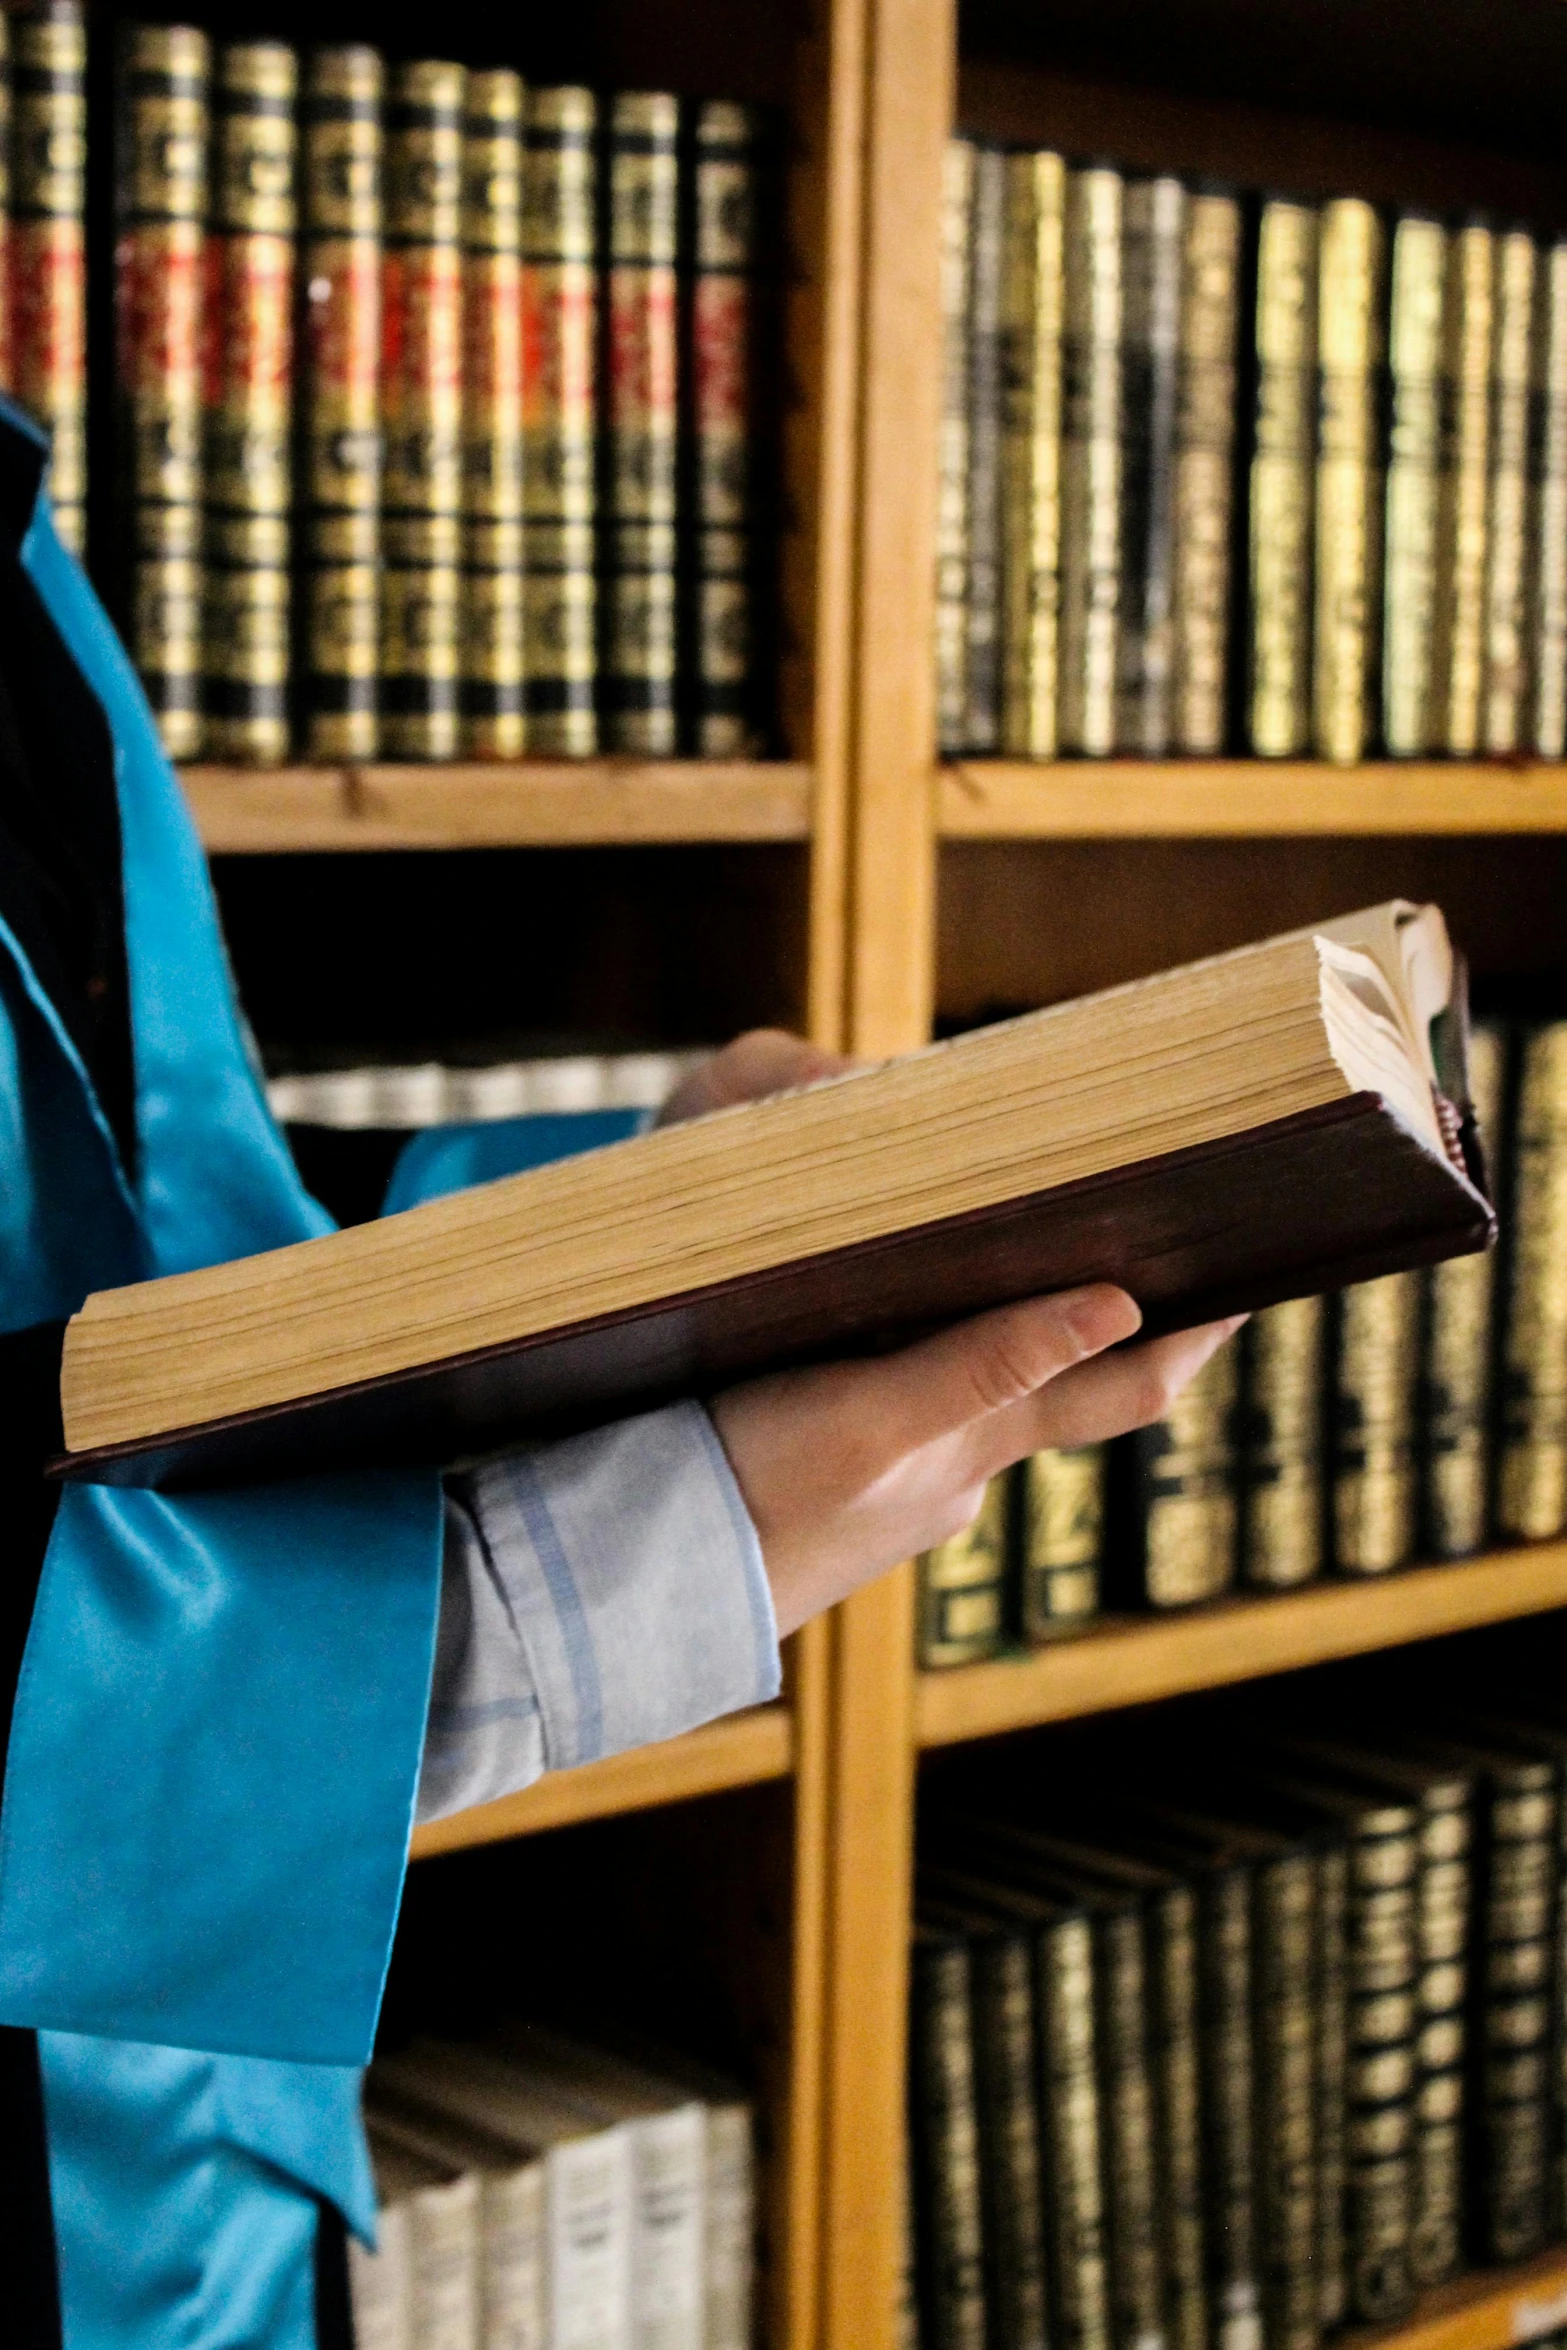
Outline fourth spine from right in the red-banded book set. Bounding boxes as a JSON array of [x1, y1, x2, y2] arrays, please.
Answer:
[[458, 73, 524, 759]]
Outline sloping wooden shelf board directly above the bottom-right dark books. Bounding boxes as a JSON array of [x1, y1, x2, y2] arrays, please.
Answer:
[[914, 1542, 1567, 1746]]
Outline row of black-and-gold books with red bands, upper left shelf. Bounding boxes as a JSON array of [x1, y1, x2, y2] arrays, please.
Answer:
[[0, 0, 768, 766]]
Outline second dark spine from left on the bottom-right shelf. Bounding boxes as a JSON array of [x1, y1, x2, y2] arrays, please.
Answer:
[[970, 1934, 1048, 2350]]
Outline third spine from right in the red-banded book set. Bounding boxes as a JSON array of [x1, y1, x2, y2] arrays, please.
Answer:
[[522, 87, 599, 759]]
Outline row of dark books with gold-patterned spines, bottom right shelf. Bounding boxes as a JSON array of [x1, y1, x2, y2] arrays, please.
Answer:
[[909, 1654, 1567, 2350]]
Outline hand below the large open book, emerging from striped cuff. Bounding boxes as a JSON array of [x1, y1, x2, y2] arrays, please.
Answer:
[[712, 1287, 1245, 1631]]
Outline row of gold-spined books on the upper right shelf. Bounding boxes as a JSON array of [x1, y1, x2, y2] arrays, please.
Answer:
[[935, 139, 1567, 761]]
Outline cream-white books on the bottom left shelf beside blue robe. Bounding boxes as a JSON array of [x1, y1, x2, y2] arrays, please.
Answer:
[[350, 2026, 754, 2350]]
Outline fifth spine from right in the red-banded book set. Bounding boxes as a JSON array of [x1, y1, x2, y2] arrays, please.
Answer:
[[381, 61, 465, 759]]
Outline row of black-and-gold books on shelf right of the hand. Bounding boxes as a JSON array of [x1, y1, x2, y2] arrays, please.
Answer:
[[919, 1020, 1567, 1666]]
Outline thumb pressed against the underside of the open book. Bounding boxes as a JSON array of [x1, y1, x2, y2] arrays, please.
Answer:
[[879, 1281, 1142, 1452]]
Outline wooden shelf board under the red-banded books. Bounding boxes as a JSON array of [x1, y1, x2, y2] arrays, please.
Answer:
[[181, 759, 811, 855]]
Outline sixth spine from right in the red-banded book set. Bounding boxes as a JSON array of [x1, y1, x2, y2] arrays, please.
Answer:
[[298, 47, 385, 759]]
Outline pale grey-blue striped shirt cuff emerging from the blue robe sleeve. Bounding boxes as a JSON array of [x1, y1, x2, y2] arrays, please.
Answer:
[[418, 1403, 780, 1821]]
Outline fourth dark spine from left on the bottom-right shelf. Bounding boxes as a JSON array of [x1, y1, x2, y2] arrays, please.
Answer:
[[1095, 1911, 1165, 2350]]
